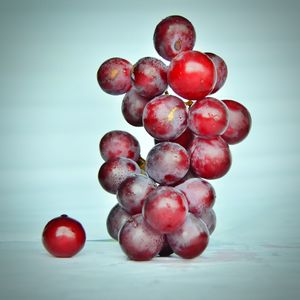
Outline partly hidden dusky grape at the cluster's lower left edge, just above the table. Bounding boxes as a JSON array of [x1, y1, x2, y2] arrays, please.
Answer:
[[106, 204, 130, 240]]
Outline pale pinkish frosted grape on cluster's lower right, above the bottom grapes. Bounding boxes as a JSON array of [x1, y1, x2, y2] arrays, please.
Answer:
[[176, 178, 216, 214]]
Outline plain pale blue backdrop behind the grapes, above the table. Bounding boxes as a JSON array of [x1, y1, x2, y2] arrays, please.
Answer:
[[0, 0, 300, 246]]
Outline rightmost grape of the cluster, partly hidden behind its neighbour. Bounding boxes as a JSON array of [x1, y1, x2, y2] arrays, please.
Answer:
[[222, 100, 251, 145]]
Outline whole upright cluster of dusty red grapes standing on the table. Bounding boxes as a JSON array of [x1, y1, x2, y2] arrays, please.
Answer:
[[97, 15, 251, 260]]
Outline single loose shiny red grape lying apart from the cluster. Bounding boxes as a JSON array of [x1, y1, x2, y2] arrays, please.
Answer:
[[42, 215, 86, 257]]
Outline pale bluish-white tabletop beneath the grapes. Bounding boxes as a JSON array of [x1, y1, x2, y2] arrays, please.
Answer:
[[0, 239, 300, 300]]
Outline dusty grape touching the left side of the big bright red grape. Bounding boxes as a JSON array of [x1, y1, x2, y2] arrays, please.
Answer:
[[131, 57, 168, 99]]
